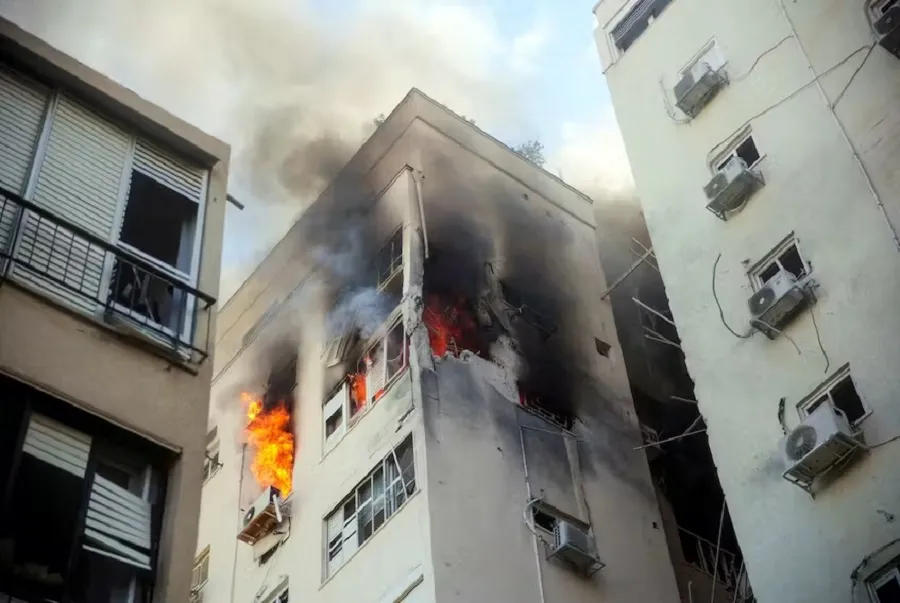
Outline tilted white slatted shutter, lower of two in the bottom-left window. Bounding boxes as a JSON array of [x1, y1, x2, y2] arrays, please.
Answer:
[[84, 475, 151, 569]]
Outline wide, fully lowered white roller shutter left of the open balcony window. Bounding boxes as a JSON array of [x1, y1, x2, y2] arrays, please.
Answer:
[[15, 93, 130, 312]]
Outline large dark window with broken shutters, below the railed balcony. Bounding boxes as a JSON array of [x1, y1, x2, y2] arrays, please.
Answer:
[[0, 402, 168, 603]]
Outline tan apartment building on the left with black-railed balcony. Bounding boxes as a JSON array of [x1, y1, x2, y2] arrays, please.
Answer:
[[0, 20, 229, 603]]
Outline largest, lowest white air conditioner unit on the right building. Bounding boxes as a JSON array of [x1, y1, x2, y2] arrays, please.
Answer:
[[781, 401, 864, 490]]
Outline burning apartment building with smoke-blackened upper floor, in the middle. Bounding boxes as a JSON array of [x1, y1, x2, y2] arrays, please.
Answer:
[[194, 90, 679, 603]]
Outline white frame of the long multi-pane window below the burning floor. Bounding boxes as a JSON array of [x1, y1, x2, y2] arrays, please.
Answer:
[[322, 433, 418, 581]]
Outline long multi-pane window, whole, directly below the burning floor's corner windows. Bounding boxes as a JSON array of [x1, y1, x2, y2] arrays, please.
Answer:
[[325, 435, 416, 578]]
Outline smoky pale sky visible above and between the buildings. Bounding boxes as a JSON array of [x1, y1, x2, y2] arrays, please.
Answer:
[[0, 0, 631, 300]]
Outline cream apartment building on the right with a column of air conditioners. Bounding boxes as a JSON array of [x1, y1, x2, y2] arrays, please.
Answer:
[[594, 0, 900, 603]]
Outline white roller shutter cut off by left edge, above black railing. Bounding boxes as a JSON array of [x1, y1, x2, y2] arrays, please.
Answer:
[[0, 67, 50, 255]]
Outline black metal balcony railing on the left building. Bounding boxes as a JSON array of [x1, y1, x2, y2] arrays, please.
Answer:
[[0, 187, 216, 362]]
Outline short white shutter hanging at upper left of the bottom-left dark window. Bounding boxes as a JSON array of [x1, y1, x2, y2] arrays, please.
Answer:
[[22, 414, 91, 478]]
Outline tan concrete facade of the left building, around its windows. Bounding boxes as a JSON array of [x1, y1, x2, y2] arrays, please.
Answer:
[[0, 19, 229, 601]]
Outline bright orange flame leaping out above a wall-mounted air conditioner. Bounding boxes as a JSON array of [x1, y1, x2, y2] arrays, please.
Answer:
[[241, 394, 294, 496]]
